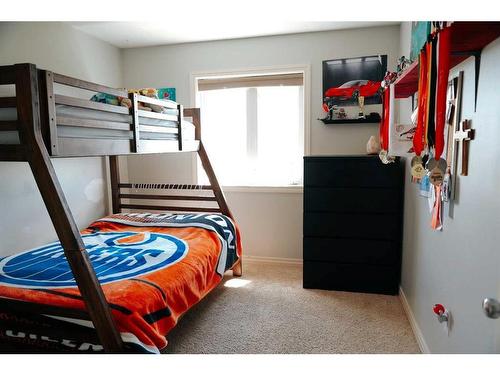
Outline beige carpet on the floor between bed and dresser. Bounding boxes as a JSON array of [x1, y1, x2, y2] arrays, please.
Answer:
[[164, 262, 419, 354]]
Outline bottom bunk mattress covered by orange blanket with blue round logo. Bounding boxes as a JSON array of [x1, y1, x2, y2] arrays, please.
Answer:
[[0, 213, 241, 353]]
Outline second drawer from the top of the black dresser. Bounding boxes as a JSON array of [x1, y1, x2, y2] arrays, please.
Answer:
[[304, 187, 402, 213]]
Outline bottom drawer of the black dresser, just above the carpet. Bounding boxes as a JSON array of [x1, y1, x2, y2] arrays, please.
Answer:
[[303, 261, 399, 294]]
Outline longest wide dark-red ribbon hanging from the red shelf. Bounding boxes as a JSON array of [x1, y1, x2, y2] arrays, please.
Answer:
[[434, 27, 451, 160]]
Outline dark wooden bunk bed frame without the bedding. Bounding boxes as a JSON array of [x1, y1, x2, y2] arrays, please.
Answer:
[[0, 64, 242, 353]]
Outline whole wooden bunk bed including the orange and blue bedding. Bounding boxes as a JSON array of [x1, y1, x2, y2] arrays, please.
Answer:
[[0, 64, 242, 353]]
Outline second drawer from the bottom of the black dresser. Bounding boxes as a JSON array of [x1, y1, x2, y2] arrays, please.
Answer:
[[303, 237, 400, 265]]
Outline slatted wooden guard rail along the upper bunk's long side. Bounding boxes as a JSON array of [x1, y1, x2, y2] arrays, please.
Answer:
[[38, 70, 188, 157]]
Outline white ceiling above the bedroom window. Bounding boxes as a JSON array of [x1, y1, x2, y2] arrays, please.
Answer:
[[70, 19, 399, 48]]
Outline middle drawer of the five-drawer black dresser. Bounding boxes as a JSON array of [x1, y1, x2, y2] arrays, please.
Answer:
[[304, 211, 401, 240]]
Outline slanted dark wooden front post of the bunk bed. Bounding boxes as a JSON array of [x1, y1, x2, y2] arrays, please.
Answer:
[[6, 64, 124, 352]]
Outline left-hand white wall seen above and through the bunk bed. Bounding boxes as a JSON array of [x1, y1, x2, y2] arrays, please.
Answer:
[[0, 22, 122, 256]]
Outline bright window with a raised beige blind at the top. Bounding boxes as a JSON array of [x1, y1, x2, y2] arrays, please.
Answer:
[[195, 72, 304, 186]]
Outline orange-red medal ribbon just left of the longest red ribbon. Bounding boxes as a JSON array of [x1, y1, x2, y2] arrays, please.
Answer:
[[413, 48, 428, 156]]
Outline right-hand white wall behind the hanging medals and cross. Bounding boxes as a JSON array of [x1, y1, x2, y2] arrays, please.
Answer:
[[401, 25, 500, 353]]
